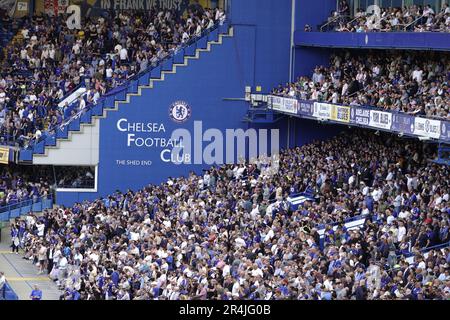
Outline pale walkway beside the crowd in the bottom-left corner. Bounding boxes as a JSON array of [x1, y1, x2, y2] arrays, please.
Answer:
[[0, 228, 61, 300]]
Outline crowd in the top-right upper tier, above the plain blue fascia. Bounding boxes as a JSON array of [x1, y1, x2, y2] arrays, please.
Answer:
[[321, 0, 450, 32]]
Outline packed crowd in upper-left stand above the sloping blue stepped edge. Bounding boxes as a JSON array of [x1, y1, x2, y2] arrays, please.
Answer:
[[0, 7, 225, 145]]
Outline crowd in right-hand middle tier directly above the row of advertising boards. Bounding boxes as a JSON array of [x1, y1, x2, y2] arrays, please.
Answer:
[[272, 51, 450, 120]]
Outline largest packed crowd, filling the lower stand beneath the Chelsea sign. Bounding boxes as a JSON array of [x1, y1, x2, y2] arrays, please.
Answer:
[[13, 131, 450, 300]]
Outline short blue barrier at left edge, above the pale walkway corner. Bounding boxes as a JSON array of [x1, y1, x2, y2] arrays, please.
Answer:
[[0, 196, 53, 221]]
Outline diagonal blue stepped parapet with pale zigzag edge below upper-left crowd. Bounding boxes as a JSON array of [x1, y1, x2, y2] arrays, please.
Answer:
[[28, 24, 234, 161]]
